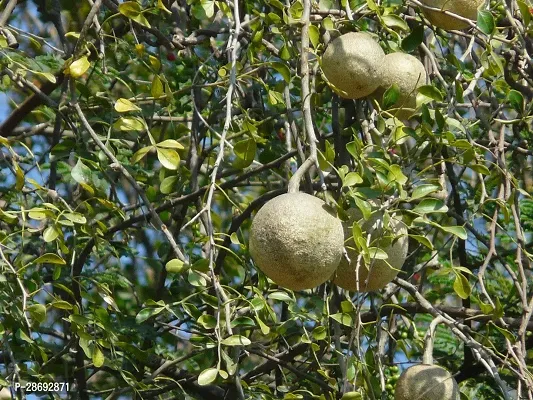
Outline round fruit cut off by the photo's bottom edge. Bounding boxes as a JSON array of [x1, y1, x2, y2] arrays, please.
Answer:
[[394, 364, 460, 400]]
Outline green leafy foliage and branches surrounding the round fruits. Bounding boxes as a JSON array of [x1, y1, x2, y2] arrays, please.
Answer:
[[0, 0, 533, 400]]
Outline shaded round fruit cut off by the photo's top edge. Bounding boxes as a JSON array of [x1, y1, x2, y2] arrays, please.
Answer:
[[421, 0, 485, 30]]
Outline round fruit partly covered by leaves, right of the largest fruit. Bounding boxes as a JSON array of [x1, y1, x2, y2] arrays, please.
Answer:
[[333, 209, 408, 292]]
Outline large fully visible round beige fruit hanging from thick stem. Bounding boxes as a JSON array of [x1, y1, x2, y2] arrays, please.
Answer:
[[249, 193, 344, 290]]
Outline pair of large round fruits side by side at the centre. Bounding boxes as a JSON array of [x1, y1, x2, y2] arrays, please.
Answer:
[[249, 193, 408, 292]]
